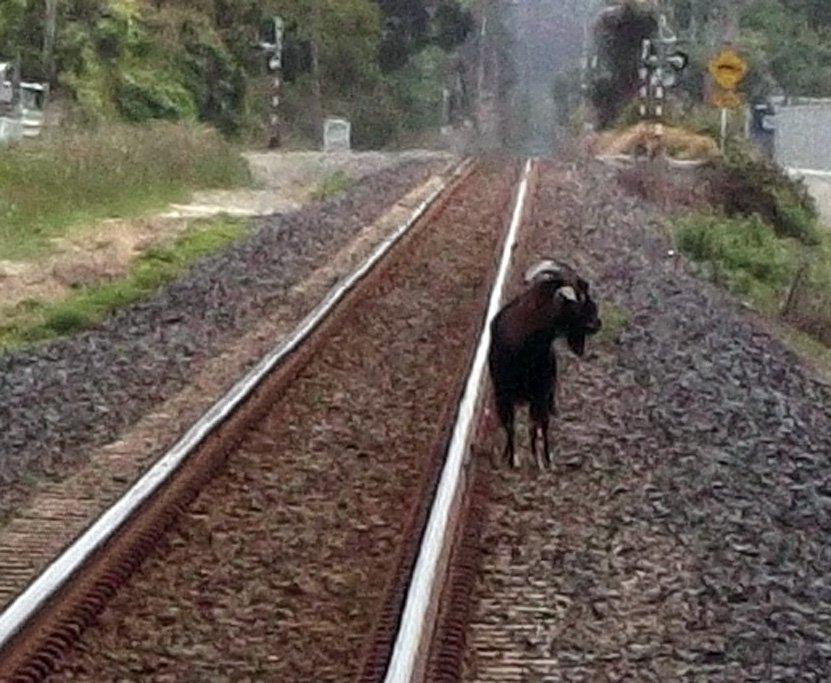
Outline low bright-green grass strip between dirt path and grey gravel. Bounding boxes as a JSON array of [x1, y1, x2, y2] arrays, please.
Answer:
[[0, 218, 247, 350]]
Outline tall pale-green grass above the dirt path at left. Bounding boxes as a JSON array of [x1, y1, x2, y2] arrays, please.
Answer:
[[0, 122, 250, 260]]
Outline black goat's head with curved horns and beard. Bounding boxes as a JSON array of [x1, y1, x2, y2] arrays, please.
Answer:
[[525, 259, 603, 356]]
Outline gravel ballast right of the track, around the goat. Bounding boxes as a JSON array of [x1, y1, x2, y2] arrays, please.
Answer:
[[466, 166, 831, 681]]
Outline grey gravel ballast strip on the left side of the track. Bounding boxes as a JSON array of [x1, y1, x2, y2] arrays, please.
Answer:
[[0, 161, 447, 484]]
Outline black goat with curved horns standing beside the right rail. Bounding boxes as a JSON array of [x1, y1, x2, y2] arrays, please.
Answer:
[[488, 261, 602, 466]]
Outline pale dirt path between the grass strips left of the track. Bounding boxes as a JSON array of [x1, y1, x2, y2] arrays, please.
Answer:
[[0, 150, 456, 312]]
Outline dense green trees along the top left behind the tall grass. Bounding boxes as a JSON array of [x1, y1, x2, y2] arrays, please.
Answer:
[[0, 0, 472, 144]]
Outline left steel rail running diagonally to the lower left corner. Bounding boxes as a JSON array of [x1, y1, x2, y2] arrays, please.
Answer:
[[0, 159, 472, 650]]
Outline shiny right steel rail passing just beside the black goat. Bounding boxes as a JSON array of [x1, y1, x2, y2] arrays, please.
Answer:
[[384, 159, 534, 683]]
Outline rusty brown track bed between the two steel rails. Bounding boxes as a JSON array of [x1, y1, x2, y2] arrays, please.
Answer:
[[0, 162, 517, 681]]
